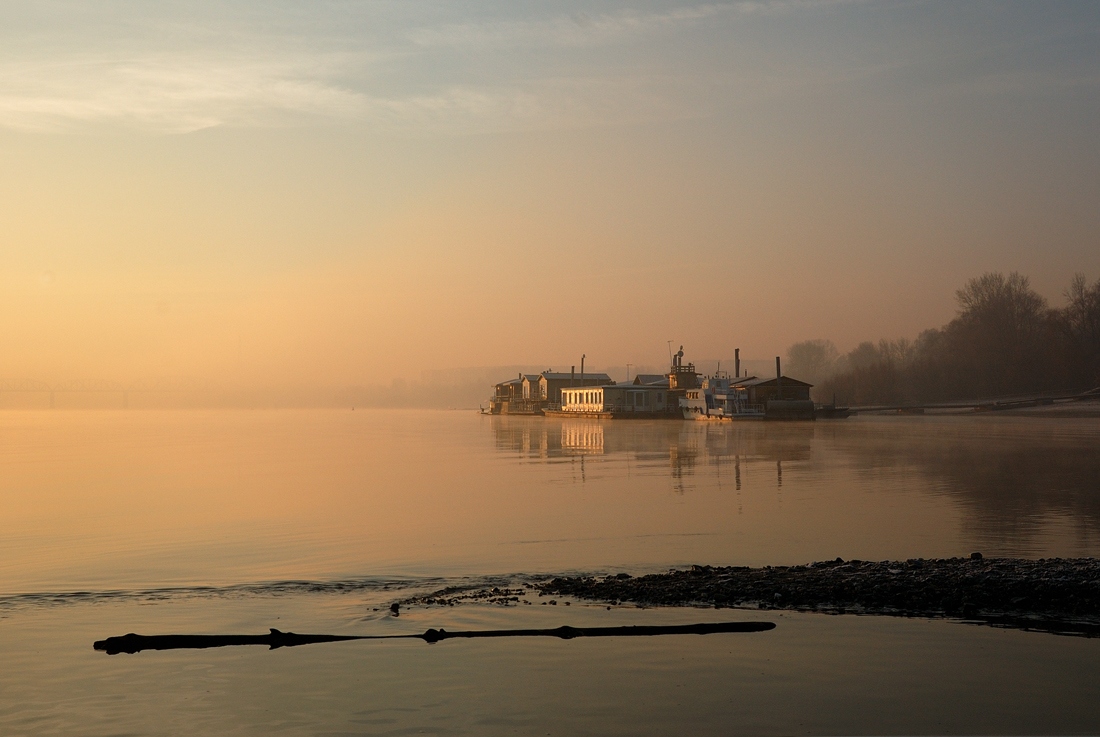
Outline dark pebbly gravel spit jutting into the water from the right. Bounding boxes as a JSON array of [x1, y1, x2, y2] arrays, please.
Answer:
[[536, 553, 1100, 637]]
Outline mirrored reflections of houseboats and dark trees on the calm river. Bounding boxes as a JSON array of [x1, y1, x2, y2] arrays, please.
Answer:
[[492, 417, 1100, 554]]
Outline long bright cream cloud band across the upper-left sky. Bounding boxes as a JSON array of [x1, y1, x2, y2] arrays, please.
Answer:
[[0, 59, 699, 133]]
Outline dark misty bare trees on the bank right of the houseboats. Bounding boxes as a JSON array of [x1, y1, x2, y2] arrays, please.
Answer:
[[790, 272, 1100, 405]]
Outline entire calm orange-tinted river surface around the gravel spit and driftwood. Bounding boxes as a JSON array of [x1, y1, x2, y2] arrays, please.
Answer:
[[0, 410, 1100, 735]]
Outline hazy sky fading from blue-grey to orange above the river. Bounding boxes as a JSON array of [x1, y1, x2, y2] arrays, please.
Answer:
[[0, 0, 1100, 386]]
